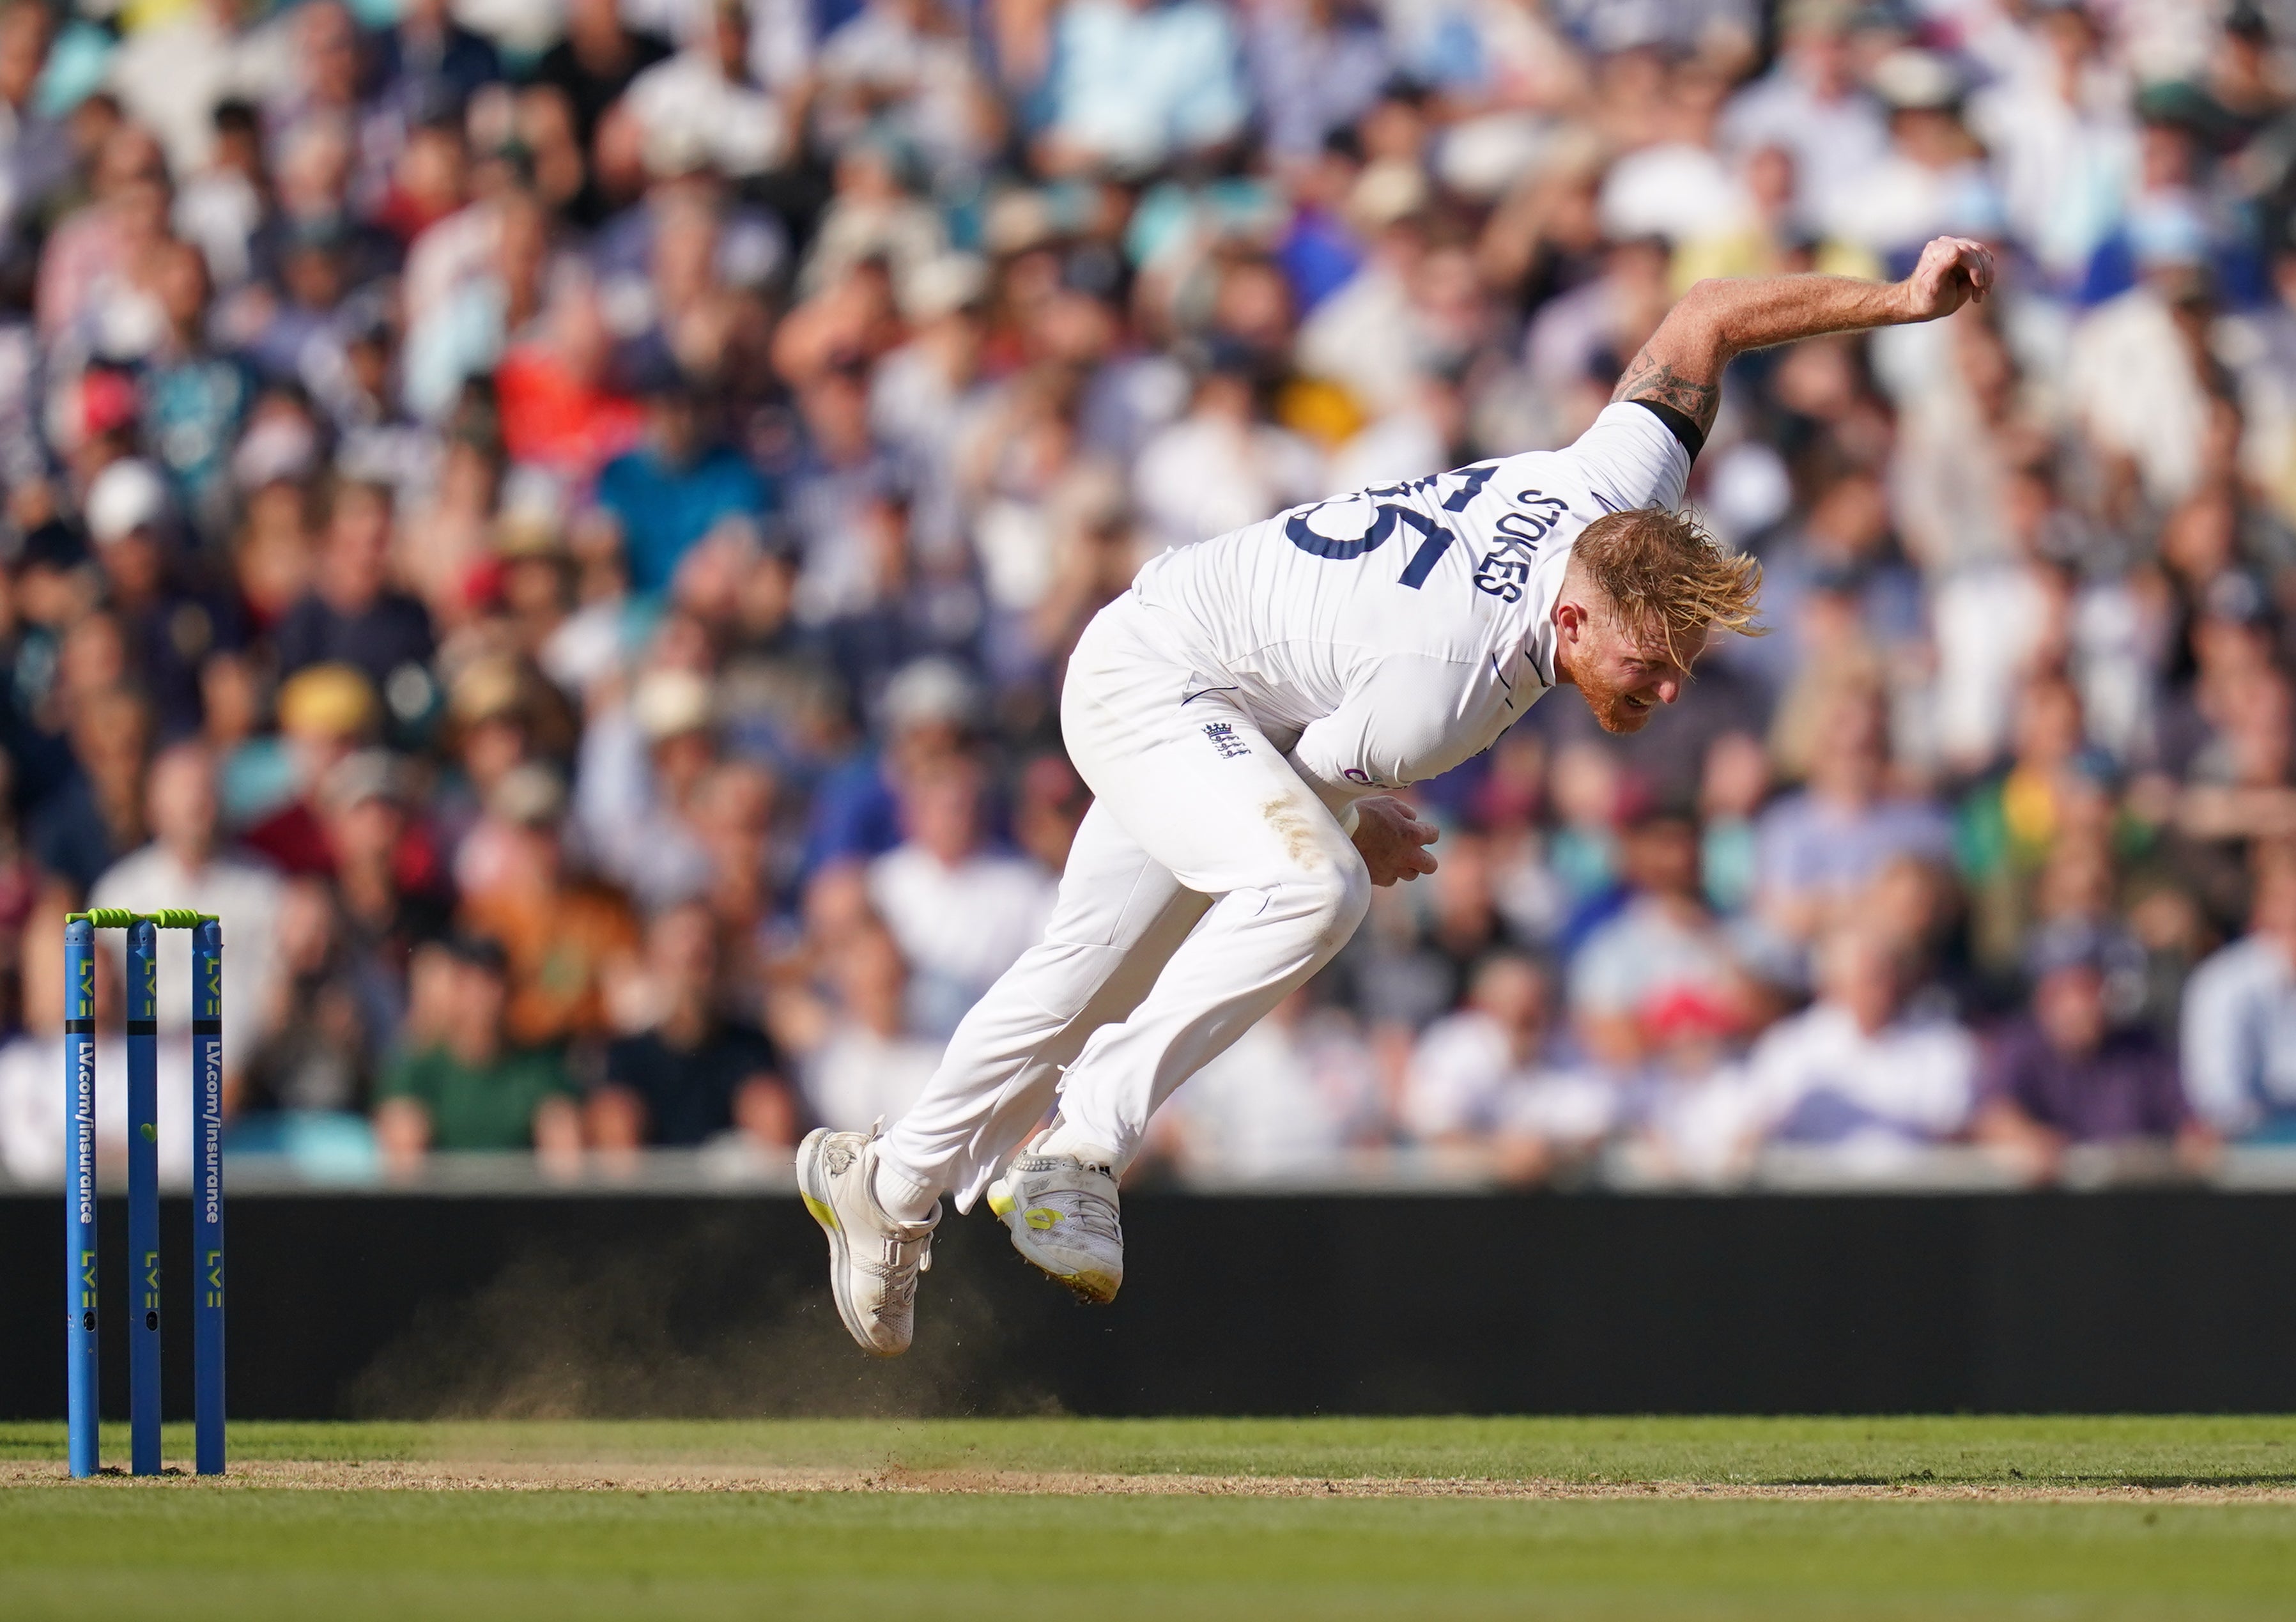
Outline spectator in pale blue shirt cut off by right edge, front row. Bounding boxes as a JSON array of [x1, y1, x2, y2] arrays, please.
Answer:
[[2184, 843, 2296, 1144]]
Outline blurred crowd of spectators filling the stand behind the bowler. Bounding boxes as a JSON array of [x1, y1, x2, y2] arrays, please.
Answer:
[[0, 0, 2296, 1183]]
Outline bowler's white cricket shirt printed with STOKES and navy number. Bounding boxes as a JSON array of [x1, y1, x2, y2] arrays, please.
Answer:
[[1132, 402, 1690, 808]]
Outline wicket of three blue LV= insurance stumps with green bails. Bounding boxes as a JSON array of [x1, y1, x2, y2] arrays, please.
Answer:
[[65, 908, 225, 1475]]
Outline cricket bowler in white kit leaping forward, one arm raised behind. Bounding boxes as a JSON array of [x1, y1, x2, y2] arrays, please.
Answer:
[[797, 236, 1993, 1356]]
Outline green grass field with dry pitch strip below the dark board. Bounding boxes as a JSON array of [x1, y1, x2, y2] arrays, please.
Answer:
[[0, 1417, 2296, 1622]]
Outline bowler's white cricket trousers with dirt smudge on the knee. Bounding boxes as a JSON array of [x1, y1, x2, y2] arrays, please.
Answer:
[[879, 592, 1371, 1211]]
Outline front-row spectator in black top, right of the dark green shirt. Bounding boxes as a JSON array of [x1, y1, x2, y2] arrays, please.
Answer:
[[583, 903, 797, 1148]]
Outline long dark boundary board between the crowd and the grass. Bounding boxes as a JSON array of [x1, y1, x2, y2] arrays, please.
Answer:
[[0, 1193, 2296, 1417]]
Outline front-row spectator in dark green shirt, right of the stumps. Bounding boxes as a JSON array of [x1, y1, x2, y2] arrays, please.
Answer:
[[374, 938, 581, 1171]]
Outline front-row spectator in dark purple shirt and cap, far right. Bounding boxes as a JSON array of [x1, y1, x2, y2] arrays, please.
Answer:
[[1975, 922, 2207, 1181]]
